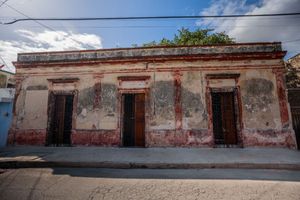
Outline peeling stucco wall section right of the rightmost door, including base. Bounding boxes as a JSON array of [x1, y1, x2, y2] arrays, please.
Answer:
[[240, 70, 295, 147]]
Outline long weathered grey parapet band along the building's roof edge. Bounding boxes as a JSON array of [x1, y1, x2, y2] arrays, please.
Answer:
[[17, 42, 282, 64]]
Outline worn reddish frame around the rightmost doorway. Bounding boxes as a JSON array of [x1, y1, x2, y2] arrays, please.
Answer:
[[206, 86, 243, 147]]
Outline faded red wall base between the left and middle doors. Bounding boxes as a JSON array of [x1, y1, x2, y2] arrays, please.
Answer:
[[71, 130, 121, 146]]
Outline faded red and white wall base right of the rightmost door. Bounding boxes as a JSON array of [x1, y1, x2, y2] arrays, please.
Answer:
[[243, 129, 297, 149]]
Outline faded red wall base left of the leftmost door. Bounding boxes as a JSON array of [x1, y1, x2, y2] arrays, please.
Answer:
[[7, 129, 46, 145]]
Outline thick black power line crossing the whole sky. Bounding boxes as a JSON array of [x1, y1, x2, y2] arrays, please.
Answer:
[[3, 11, 300, 25]]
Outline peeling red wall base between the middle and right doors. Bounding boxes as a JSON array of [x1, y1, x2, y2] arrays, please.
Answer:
[[146, 129, 213, 147]]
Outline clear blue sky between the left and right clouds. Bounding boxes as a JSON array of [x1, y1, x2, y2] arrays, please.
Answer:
[[0, 0, 209, 48]]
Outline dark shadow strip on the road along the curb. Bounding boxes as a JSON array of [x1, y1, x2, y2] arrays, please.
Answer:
[[52, 168, 300, 182]]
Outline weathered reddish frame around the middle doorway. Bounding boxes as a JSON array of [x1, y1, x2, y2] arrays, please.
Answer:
[[117, 88, 150, 147]]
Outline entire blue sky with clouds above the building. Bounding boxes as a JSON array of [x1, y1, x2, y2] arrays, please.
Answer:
[[0, 0, 300, 71]]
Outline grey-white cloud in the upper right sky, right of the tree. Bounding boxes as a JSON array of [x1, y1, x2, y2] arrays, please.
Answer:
[[197, 0, 300, 56]]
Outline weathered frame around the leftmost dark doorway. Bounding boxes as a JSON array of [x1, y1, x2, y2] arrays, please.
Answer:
[[46, 90, 78, 146]]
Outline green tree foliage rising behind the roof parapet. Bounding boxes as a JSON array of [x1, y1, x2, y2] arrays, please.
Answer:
[[143, 28, 235, 47]]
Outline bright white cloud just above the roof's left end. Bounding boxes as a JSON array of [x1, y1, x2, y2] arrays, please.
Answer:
[[0, 29, 102, 71]]
